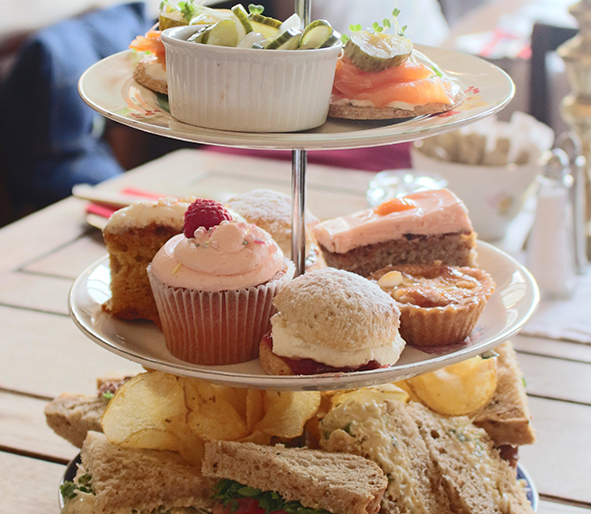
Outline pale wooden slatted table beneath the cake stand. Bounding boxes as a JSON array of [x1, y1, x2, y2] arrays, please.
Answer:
[[0, 150, 591, 514]]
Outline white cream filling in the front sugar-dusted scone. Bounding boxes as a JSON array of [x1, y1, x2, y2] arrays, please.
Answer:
[[271, 314, 406, 368]]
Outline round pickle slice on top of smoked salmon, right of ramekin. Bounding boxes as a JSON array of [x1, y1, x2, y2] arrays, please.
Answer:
[[345, 30, 412, 73]]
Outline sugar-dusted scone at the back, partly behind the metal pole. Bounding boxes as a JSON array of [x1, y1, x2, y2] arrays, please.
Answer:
[[226, 189, 326, 271]]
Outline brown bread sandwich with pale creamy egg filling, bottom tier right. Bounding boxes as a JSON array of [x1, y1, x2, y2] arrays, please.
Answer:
[[320, 398, 533, 514]]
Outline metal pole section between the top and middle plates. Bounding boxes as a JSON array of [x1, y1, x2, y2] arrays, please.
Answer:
[[291, 150, 307, 276]]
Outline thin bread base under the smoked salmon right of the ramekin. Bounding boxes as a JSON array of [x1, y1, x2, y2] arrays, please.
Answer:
[[328, 87, 466, 120]]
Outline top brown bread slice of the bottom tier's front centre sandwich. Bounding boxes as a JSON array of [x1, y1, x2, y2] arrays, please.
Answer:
[[202, 441, 388, 514]]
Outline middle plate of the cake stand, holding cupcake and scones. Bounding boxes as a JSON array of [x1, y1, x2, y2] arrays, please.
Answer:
[[68, 242, 539, 391]]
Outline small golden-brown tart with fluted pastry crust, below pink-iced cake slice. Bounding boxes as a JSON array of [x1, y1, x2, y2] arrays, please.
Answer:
[[370, 262, 495, 346]]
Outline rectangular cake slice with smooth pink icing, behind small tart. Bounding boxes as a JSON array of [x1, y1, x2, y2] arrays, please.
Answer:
[[313, 189, 476, 277]]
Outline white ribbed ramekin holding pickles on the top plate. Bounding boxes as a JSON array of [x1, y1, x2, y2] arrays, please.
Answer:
[[162, 26, 341, 132]]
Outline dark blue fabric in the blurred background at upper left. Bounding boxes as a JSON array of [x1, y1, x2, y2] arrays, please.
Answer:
[[0, 3, 151, 207]]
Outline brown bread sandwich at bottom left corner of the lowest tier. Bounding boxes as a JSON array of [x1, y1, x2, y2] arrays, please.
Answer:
[[61, 432, 213, 514]]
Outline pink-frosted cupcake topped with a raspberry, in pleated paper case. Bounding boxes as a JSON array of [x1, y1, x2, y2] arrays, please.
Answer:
[[148, 199, 294, 365]]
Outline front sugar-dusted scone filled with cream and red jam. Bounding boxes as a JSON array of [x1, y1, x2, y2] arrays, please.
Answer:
[[259, 268, 405, 375]]
